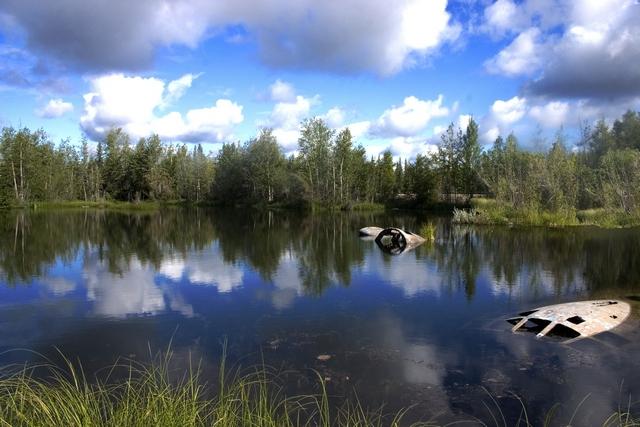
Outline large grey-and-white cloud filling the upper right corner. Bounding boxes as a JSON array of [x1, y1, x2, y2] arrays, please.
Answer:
[[485, 0, 640, 100]]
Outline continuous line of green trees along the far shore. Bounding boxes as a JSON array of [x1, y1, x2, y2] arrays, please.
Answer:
[[0, 111, 640, 213]]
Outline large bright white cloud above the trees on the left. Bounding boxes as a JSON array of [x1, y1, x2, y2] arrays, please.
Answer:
[[80, 74, 244, 142]]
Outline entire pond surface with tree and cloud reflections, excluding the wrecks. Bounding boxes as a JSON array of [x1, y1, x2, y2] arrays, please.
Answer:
[[0, 209, 640, 425]]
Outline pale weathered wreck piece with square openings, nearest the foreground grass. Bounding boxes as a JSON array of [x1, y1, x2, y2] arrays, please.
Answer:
[[507, 300, 631, 342]]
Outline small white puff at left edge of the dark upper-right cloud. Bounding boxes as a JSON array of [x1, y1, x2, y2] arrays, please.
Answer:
[[485, 28, 542, 76]]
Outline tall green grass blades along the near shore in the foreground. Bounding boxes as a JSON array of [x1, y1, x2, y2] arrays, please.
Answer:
[[0, 353, 640, 427]]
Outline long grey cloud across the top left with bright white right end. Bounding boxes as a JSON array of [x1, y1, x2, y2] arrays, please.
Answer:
[[0, 0, 460, 75]]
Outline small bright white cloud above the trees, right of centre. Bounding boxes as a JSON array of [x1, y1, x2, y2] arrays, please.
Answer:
[[370, 95, 449, 137]]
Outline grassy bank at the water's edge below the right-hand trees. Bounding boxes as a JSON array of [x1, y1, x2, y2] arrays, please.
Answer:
[[453, 198, 640, 228]]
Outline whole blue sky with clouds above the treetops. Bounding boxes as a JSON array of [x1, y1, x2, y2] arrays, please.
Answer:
[[0, 0, 640, 158]]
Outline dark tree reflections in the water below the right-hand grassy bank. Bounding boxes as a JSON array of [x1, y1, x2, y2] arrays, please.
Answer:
[[429, 223, 640, 298]]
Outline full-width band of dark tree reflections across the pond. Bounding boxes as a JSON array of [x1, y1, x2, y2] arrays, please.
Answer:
[[0, 208, 640, 299]]
